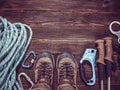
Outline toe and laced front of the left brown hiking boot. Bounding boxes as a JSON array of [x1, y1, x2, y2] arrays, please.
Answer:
[[34, 52, 55, 85]]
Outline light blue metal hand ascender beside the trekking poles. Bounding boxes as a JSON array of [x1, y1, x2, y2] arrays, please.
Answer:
[[80, 48, 97, 86]]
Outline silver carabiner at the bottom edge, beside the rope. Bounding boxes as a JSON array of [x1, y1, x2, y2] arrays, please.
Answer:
[[18, 72, 34, 90]]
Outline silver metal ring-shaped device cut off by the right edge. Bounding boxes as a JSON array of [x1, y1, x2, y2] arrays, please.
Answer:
[[109, 21, 120, 44]]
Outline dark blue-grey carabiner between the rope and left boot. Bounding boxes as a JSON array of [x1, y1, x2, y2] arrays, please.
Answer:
[[22, 51, 37, 69]]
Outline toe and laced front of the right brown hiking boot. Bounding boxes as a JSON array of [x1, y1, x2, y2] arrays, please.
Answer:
[[56, 52, 78, 90]]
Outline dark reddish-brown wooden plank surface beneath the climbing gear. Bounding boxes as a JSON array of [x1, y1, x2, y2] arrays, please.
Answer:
[[0, 0, 120, 90]]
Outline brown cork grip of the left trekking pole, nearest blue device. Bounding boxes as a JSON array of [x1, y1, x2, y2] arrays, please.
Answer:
[[95, 39, 105, 64]]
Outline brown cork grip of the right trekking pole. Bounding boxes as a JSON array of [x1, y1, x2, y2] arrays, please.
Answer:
[[104, 37, 113, 62]]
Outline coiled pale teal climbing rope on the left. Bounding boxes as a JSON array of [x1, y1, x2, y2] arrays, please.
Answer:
[[0, 17, 32, 90]]
